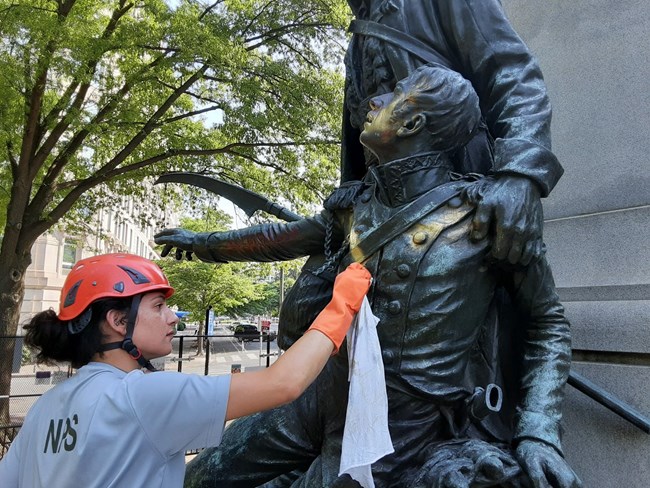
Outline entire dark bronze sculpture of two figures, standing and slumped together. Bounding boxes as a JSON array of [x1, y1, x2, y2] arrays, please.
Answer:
[[157, 0, 580, 487]]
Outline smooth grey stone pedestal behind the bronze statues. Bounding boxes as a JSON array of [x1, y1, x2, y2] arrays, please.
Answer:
[[503, 0, 650, 488]]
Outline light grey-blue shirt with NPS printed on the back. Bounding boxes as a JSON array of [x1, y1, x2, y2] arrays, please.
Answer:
[[0, 363, 230, 488]]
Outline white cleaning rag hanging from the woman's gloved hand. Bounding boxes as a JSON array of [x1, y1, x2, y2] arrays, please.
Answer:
[[339, 298, 394, 488]]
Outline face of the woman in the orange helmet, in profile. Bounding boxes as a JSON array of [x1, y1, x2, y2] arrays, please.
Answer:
[[133, 292, 179, 359]]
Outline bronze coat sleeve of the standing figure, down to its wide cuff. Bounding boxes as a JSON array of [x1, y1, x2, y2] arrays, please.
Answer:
[[434, 0, 564, 196]]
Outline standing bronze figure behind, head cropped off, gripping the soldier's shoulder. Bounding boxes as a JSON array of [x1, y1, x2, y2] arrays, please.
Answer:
[[341, 0, 563, 264]]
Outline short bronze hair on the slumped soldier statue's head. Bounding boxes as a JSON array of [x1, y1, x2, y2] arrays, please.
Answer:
[[393, 65, 481, 151]]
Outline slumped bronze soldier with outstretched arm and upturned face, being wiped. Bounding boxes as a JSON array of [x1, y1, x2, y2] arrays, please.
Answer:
[[157, 66, 580, 488]]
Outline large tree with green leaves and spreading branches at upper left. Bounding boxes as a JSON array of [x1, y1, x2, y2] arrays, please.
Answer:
[[0, 0, 348, 432]]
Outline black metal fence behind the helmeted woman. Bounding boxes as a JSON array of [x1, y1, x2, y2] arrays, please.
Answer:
[[0, 330, 279, 459]]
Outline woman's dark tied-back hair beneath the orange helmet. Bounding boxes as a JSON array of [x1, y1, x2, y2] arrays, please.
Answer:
[[24, 298, 131, 368]]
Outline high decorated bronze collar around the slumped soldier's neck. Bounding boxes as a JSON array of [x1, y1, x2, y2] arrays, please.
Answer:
[[369, 152, 452, 207]]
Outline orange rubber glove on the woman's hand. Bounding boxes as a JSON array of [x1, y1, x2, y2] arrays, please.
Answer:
[[309, 263, 372, 355]]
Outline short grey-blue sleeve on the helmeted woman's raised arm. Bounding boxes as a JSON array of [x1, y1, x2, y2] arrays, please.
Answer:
[[127, 372, 230, 456]]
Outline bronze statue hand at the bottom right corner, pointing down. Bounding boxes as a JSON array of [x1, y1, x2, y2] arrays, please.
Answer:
[[515, 440, 582, 488]]
